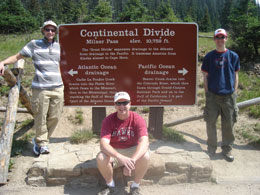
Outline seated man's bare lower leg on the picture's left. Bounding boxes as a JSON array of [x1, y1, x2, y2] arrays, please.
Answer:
[[97, 152, 113, 183]]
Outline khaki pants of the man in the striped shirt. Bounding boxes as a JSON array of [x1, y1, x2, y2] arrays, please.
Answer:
[[31, 86, 64, 146]]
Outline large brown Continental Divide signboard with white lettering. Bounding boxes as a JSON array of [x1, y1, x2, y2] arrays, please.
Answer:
[[59, 23, 198, 106]]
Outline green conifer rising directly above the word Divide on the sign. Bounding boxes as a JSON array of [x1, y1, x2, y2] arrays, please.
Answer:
[[155, 1, 179, 22]]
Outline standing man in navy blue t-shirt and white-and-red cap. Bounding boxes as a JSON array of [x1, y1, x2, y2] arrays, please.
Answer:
[[201, 29, 240, 162]]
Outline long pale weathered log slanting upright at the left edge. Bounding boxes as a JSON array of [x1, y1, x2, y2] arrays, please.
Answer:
[[0, 61, 22, 184]]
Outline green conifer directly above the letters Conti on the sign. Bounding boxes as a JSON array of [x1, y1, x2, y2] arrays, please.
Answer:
[[88, 0, 112, 22]]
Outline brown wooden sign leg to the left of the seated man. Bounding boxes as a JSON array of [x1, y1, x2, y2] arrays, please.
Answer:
[[92, 107, 106, 135]]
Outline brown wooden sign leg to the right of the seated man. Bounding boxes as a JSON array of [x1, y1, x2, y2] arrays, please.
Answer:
[[148, 107, 163, 139]]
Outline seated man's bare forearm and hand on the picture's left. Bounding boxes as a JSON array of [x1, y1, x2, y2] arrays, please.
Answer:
[[100, 138, 135, 172]]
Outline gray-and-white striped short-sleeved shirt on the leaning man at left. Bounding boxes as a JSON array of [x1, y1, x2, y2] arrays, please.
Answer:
[[20, 38, 63, 89]]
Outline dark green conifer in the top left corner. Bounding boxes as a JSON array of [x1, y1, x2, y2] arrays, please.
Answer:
[[0, 0, 37, 33]]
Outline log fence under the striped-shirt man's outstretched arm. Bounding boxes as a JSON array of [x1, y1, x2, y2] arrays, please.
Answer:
[[0, 59, 32, 184]]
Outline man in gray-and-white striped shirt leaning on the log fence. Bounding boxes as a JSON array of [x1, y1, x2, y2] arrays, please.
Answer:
[[0, 20, 64, 156]]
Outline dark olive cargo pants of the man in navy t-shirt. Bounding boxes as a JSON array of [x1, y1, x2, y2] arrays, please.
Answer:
[[204, 92, 238, 152]]
